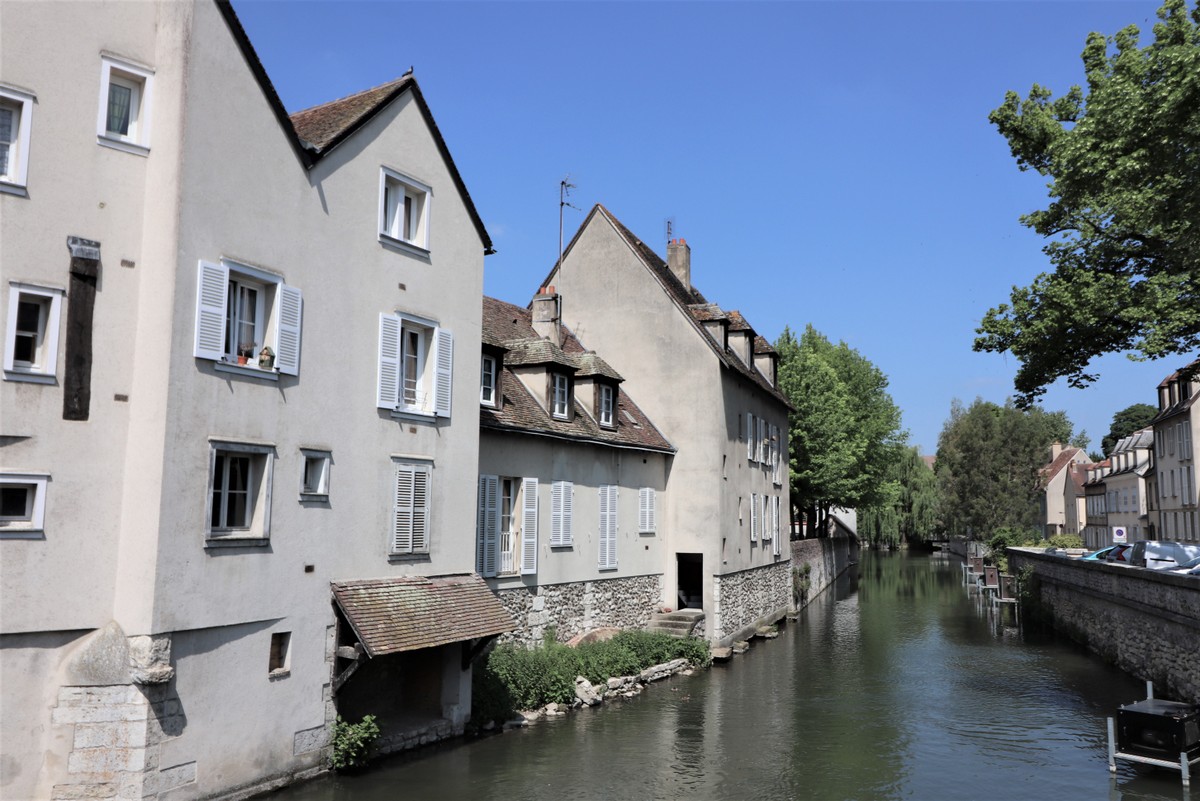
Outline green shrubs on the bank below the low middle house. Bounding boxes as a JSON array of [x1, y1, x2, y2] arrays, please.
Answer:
[[472, 631, 712, 723]]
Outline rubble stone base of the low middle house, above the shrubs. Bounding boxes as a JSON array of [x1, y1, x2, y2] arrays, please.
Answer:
[[497, 573, 662, 648]]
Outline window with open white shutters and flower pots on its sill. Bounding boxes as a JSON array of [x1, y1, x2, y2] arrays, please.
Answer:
[[192, 260, 304, 378]]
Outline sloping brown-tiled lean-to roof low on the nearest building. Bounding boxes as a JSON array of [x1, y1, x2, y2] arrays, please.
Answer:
[[332, 573, 515, 657]]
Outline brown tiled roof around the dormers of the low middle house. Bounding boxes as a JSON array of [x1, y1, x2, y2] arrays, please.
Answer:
[[479, 297, 674, 453]]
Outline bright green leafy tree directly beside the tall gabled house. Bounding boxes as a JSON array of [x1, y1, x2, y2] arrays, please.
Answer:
[[775, 325, 904, 531]]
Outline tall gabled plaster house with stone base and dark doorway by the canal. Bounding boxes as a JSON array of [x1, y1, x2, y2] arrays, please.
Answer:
[[542, 205, 791, 643]]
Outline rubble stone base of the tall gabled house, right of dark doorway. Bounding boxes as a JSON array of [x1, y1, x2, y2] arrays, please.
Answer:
[[713, 561, 792, 645]]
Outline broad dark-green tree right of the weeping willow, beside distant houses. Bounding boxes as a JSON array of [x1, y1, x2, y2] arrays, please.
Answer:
[[936, 398, 1072, 540]]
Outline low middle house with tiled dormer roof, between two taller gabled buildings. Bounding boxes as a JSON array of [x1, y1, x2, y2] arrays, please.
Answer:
[[476, 293, 674, 645]]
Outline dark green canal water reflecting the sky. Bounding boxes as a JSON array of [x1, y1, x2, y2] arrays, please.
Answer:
[[271, 552, 1200, 801]]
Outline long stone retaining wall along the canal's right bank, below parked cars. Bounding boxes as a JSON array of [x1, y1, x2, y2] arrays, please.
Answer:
[[1008, 548, 1200, 704]]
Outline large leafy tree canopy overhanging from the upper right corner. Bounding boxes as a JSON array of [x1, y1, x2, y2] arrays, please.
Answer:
[[974, 0, 1200, 405]]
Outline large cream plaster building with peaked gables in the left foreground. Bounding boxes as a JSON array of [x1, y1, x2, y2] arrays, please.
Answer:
[[0, 0, 511, 799]]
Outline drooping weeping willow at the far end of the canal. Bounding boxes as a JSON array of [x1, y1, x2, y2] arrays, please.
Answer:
[[858, 447, 940, 548]]
